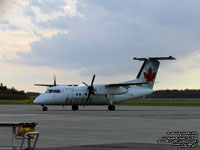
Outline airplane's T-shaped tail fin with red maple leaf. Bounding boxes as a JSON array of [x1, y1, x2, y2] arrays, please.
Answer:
[[133, 56, 175, 89]]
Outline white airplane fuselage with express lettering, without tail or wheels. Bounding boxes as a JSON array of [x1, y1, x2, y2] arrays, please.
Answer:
[[34, 84, 153, 105]]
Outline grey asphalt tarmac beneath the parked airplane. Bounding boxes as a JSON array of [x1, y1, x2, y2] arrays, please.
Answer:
[[0, 105, 200, 150]]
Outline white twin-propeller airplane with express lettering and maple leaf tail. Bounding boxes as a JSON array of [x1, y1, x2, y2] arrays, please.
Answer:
[[34, 56, 175, 111]]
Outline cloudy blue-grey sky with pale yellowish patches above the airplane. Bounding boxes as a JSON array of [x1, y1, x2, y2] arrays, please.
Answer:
[[0, 0, 200, 92]]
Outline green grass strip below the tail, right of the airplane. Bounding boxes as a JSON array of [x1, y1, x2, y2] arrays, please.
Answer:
[[117, 98, 200, 106]]
